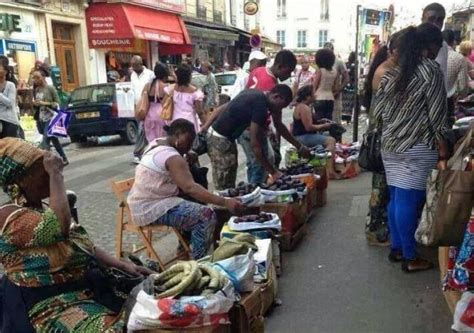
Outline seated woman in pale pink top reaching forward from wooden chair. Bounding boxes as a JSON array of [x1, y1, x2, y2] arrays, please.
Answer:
[[128, 119, 242, 259]]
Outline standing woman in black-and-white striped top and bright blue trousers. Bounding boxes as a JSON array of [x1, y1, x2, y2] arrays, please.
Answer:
[[374, 23, 449, 272]]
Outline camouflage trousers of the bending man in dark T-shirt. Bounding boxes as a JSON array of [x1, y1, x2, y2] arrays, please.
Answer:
[[207, 134, 238, 191]]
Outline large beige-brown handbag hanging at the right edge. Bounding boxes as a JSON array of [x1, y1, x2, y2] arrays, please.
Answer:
[[415, 129, 474, 246]]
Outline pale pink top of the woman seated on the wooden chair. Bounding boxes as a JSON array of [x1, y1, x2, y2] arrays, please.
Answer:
[[127, 142, 184, 226]]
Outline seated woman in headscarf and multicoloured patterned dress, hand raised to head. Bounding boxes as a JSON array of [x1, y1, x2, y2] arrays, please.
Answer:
[[0, 138, 150, 333]]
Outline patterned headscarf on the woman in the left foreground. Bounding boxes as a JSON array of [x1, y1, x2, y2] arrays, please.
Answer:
[[0, 138, 44, 189]]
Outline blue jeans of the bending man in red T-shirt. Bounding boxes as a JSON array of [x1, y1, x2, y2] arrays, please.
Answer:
[[238, 130, 275, 184]]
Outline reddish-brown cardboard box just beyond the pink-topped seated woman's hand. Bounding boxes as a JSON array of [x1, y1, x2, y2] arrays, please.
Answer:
[[261, 199, 308, 234]]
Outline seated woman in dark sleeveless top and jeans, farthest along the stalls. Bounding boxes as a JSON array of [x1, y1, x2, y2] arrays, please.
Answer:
[[292, 86, 338, 179]]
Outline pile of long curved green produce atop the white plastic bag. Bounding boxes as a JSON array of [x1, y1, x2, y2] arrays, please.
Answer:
[[154, 261, 228, 298]]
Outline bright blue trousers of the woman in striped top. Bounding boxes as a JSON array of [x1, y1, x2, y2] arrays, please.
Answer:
[[388, 186, 426, 260]]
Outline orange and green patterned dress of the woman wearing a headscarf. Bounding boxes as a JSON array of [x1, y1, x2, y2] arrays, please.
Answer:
[[0, 205, 124, 333]]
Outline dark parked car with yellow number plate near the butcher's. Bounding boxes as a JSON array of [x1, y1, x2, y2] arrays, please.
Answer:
[[66, 82, 138, 144]]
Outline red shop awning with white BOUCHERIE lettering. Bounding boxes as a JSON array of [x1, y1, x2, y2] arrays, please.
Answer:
[[86, 3, 191, 48]]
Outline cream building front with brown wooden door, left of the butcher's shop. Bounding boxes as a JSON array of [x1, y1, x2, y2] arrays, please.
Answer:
[[0, 0, 91, 91]]
